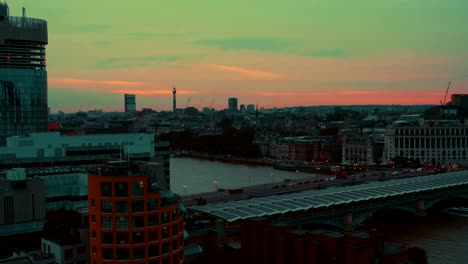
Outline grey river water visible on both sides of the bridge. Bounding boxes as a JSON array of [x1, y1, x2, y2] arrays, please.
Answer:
[[171, 158, 468, 264]]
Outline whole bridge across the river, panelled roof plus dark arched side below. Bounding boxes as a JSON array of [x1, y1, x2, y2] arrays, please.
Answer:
[[189, 171, 468, 231]]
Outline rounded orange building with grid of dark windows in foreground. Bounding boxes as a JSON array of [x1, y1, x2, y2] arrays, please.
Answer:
[[88, 165, 184, 264]]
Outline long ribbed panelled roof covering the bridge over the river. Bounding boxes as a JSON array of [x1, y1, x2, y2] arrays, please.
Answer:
[[190, 171, 468, 222]]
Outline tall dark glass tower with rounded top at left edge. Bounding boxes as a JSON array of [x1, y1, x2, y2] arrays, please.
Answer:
[[0, 3, 48, 144]]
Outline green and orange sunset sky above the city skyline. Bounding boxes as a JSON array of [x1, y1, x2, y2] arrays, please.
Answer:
[[7, 0, 468, 112]]
